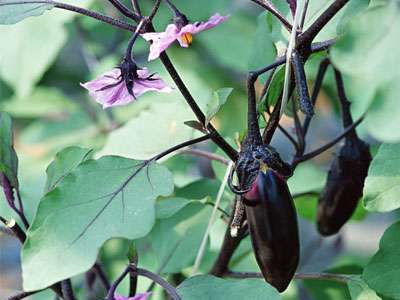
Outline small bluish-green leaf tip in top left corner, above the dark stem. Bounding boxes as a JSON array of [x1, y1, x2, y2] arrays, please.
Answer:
[[0, 0, 54, 24]]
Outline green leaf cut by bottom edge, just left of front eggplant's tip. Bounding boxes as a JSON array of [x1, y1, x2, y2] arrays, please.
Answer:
[[177, 275, 281, 300]]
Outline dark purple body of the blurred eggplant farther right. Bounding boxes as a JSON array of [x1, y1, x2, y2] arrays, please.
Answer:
[[317, 138, 372, 236]]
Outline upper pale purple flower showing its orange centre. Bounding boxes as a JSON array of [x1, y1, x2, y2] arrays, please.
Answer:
[[142, 13, 229, 60]]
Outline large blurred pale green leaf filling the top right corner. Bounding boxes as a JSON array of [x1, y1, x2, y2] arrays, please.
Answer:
[[331, 1, 400, 142]]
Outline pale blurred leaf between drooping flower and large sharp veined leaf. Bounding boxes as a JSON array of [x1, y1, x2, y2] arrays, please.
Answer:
[[98, 99, 193, 159]]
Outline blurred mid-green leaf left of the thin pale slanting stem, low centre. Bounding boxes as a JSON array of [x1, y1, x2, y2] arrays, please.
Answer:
[[138, 200, 212, 273]]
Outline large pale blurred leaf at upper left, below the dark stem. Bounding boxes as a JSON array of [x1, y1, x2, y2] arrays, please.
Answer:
[[0, 0, 91, 98]]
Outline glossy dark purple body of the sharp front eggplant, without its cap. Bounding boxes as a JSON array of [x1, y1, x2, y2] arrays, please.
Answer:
[[245, 170, 300, 292]]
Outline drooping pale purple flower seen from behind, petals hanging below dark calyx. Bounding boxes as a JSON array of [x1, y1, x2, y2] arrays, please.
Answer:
[[81, 68, 172, 108]]
